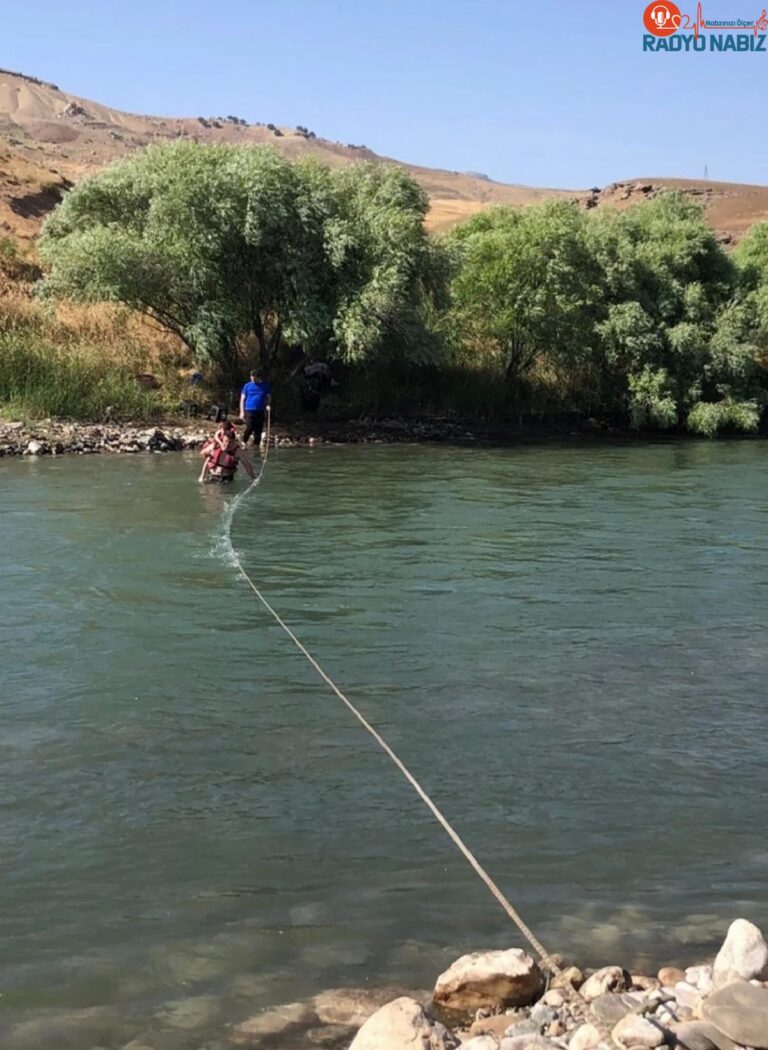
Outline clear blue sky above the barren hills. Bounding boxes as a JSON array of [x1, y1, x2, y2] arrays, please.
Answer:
[[0, 0, 768, 187]]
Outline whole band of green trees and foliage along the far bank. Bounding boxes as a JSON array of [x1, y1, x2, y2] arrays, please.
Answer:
[[31, 143, 768, 436]]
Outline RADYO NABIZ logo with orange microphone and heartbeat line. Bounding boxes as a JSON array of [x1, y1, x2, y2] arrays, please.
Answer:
[[643, 0, 768, 54]]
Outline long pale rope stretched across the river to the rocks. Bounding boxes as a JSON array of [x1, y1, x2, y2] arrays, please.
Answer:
[[219, 412, 561, 973]]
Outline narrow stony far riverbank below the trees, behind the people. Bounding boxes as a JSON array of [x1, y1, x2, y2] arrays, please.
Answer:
[[0, 417, 744, 457]]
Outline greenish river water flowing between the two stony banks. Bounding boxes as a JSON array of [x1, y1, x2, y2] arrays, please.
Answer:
[[0, 442, 768, 1050]]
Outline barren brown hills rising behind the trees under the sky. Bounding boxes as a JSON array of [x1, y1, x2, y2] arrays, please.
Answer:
[[0, 71, 768, 240]]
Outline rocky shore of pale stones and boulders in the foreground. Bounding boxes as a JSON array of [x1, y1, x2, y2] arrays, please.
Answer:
[[226, 919, 768, 1050]]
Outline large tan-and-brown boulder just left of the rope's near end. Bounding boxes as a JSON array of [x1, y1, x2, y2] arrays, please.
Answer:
[[433, 948, 544, 1014]]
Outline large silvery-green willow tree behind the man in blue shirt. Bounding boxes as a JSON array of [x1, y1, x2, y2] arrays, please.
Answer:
[[40, 142, 445, 373]]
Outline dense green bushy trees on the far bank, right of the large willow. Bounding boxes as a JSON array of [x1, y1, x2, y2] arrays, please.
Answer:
[[448, 193, 768, 435]]
